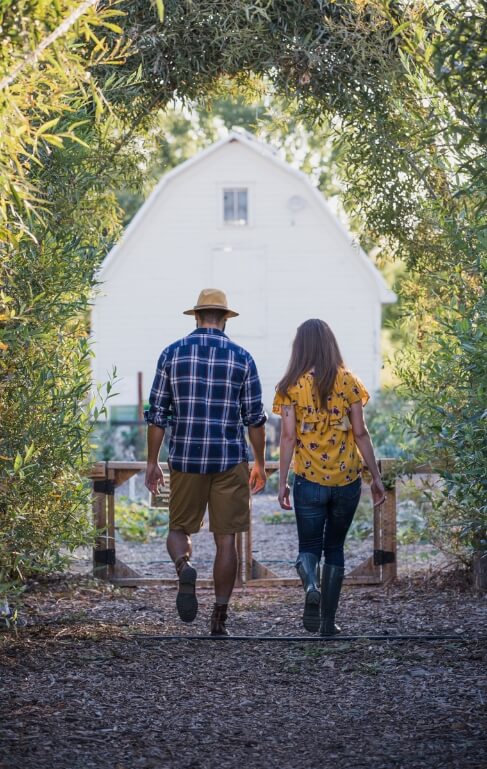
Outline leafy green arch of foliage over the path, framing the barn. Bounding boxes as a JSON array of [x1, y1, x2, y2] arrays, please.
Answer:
[[0, 0, 487, 588]]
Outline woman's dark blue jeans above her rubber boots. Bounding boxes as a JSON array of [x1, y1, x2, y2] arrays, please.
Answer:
[[293, 475, 362, 566]]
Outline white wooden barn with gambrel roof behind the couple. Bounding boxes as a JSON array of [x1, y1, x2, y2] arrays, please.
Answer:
[[92, 130, 395, 417]]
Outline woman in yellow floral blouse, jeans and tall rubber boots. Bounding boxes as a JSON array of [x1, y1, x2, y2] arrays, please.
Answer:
[[273, 320, 385, 635]]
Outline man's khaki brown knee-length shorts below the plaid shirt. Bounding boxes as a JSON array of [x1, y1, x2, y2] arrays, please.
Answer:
[[169, 462, 250, 534]]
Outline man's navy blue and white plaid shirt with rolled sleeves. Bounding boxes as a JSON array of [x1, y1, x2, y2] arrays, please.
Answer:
[[145, 328, 267, 473]]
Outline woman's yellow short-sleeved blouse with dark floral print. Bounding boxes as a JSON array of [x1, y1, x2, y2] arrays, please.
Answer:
[[272, 368, 369, 486]]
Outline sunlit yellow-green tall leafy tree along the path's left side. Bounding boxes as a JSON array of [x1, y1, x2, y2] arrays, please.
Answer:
[[0, 2, 137, 590]]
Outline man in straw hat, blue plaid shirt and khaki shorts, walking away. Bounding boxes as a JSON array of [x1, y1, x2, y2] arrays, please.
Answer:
[[145, 288, 267, 635]]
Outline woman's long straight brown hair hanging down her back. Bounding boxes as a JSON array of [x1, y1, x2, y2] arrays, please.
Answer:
[[277, 318, 343, 408]]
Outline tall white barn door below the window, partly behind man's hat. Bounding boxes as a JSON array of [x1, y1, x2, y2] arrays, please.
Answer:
[[211, 246, 269, 338]]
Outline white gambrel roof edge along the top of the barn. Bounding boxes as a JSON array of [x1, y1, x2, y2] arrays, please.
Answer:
[[99, 128, 396, 304]]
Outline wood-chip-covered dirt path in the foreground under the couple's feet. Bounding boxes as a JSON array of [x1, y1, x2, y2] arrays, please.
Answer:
[[0, 577, 487, 769]]
